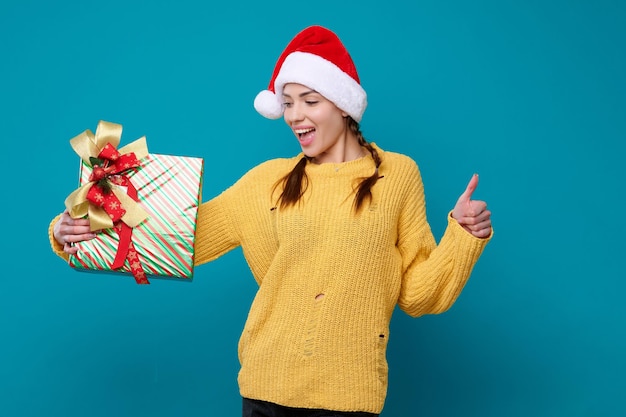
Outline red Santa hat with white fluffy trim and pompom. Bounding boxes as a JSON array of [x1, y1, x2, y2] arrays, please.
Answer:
[[254, 26, 367, 122]]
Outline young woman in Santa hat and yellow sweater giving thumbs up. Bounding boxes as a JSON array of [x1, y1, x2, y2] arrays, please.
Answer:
[[50, 26, 492, 416]]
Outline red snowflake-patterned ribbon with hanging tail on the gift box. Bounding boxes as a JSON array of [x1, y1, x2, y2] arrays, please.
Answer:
[[87, 143, 149, 284]]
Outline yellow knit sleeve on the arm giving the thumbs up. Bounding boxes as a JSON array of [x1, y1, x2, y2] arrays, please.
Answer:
[[398, 162, 493, 317]]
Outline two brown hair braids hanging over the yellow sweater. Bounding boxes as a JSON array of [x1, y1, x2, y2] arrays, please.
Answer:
[[274, 116, 381, 213]]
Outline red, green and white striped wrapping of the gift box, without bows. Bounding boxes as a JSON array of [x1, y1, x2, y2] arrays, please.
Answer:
[[69, 154, 204, 279]]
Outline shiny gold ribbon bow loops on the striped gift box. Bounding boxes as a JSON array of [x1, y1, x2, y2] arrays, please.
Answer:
[[65, 120, 148, 231]]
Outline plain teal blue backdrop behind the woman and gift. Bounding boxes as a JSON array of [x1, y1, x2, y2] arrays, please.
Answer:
[[0, 0, 626, 417]]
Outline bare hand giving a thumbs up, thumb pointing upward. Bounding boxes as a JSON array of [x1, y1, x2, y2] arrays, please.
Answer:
[[452, 174, 491, 238]]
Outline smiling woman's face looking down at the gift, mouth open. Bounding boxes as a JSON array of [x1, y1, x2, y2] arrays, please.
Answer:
[[283, 83, 361, 164]]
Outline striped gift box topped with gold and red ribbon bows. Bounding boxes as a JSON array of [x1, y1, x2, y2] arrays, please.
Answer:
[[66, 122, 204, 284]]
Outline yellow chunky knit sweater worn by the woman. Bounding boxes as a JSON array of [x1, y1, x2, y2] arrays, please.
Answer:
[[51, 148, 489, 413]]
